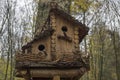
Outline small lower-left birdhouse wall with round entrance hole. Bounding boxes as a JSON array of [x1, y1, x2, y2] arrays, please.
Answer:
[[32, 37, 50, 60]]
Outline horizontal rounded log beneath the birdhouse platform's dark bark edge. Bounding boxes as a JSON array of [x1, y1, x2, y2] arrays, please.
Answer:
[[31, 68, 86, 78]]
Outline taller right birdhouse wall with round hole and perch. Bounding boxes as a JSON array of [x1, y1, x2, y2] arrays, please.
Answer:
[[52, 15, 79, 57]]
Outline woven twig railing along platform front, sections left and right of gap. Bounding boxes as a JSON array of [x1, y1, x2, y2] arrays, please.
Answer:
[[15, 52, 86, 62]]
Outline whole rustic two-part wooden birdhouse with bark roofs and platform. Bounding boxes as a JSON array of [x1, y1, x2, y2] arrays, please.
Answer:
[[15, 2, 89, 80]]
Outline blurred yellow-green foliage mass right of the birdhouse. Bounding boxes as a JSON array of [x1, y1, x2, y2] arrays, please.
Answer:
[[81, 23, 120, 80]]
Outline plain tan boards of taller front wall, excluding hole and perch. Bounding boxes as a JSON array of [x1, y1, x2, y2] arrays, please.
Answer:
[[56, 15, 74, 56]]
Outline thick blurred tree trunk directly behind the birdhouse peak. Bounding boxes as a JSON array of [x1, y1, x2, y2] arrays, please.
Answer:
[[35, 0, 72, 34]]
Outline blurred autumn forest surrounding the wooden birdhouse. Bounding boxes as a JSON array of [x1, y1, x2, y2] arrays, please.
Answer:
[[0, 0, 120, 80]]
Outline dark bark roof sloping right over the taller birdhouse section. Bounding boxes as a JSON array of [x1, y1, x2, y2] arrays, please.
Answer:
[[49, 2, 89, 43]]
